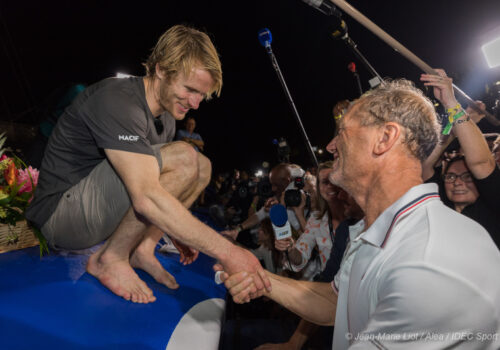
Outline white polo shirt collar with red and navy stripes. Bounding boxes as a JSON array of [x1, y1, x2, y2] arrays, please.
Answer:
[[357, 183, 439, 248]]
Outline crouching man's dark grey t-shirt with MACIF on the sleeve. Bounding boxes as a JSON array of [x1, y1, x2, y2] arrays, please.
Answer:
[[26, 77, 175, 228]]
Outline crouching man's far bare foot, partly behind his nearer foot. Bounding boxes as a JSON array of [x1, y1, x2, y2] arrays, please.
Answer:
[[130, 244, 179, 289]]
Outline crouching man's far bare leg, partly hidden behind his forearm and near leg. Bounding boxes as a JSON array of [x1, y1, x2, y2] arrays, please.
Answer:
[[130, 148, 211, 289]]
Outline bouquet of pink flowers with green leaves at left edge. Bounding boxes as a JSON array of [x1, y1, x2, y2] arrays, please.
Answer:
[[0, 133, 48, 255]]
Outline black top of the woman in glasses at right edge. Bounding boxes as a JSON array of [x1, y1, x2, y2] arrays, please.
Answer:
[[426, 167, 500, 249]]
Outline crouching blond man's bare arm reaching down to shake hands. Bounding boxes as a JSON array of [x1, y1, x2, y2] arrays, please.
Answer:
[[105, 149, 270, 289]]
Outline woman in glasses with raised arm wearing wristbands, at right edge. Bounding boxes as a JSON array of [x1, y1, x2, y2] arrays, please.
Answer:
[[421, 69, 500, 247]]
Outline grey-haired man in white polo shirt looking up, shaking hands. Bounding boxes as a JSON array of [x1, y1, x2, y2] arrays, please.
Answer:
[[218, 81, 500, 350]]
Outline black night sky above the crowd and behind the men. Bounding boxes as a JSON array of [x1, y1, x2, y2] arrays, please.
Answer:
[[0, 0, 500, 175]]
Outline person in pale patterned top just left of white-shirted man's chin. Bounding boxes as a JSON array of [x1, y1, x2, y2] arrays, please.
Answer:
[[275, 161, 344, 276]]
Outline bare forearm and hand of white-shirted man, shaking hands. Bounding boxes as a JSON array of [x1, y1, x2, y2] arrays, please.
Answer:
[[220, 266, 337, 326]]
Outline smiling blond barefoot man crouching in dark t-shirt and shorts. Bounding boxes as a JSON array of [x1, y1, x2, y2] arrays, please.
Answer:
[[27, 25, 265, 303]]
